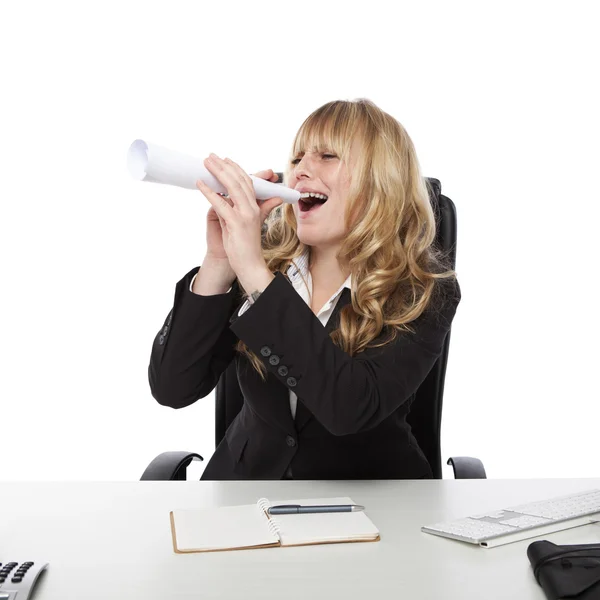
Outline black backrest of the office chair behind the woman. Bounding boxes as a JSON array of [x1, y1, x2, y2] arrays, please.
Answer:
[[215, 175, 456, 479]]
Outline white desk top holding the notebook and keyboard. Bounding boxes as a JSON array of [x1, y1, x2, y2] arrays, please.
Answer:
[[0, 479, 600, 600]]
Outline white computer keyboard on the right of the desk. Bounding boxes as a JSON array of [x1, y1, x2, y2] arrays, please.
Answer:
[[421, 490, 600, 548]]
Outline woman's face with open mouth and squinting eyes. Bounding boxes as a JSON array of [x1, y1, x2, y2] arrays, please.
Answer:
[[288, 142, 354, 248]]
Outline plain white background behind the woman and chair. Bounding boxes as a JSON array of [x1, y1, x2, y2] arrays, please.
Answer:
[[0, 0, 600, 480]]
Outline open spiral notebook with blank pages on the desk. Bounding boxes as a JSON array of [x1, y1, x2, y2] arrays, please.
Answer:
[[170, 497, 380, 553]]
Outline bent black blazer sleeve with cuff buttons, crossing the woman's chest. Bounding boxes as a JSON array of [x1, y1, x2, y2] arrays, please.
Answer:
[[231, 273, 460, 435]]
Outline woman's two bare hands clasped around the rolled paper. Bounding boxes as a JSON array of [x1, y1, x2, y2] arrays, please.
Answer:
[[196, 154, 283, 275]]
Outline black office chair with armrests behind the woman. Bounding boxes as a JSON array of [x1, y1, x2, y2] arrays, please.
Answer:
[[141, 173, 486, 481]]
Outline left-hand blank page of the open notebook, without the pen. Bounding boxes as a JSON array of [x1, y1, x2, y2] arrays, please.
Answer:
[[171, 504, 279, 552]]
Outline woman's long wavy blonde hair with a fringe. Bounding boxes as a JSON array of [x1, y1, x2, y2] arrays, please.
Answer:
[[235, 98, 456, 381]]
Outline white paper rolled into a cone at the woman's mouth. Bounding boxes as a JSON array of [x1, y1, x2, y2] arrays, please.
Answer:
[[127, 140, 300, 204]]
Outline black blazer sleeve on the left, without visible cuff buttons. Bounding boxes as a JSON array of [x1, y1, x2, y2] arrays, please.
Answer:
[[148, 267, 241, 408]]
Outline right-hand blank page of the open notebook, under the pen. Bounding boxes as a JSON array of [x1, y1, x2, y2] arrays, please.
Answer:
[[270, 497, 379, 546]]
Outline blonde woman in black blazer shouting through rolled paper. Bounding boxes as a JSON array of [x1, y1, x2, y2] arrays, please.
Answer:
[[149, 99, 460, 479]]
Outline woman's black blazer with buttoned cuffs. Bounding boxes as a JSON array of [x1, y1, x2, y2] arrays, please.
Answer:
[[148, 267, 460, 480]]
